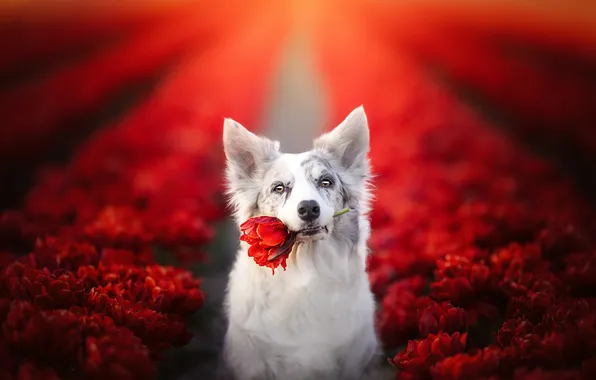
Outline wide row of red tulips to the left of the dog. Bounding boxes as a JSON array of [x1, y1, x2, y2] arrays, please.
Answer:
[[0, 46, 215, 379]]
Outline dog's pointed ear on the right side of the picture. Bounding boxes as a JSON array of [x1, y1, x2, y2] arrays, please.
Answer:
[[314, 106, 370, 171]]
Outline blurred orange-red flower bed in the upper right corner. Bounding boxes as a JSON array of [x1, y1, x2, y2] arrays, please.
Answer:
[[355, 0, 596, 161]]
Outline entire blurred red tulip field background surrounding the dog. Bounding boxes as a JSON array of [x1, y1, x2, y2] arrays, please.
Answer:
[[0, 0, 596, 379]]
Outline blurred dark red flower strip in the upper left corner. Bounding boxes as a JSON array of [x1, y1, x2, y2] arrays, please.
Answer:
[[0, 0, 201, 72]]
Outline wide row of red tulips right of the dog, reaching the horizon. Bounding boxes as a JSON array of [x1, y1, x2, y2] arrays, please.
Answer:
[[317, 1, 596, 379]]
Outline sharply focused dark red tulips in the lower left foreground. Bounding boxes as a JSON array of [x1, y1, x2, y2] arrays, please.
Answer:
[[0, 238, 203, 379]]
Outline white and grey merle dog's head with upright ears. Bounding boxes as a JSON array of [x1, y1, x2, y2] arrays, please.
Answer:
[[223, 107, 369, 240]]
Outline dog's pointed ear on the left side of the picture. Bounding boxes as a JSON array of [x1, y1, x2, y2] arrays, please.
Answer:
[[223, 119, 279, 180]]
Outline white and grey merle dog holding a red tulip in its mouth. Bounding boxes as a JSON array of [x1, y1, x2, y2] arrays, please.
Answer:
[[223, 106, 379, 380]]
